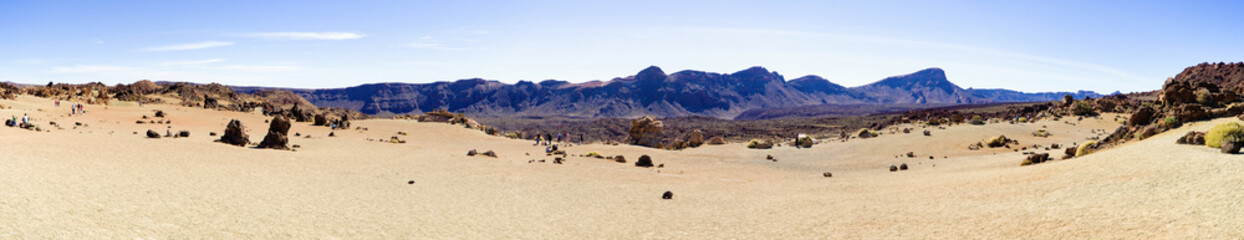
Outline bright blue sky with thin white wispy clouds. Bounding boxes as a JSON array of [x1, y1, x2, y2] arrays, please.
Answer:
[[0, 0, 1244, 92]]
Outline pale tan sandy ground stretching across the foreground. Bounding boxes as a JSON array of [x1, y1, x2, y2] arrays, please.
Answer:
[[0, 96, 1244, 239]]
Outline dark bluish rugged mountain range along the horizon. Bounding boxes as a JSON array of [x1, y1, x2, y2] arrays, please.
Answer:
[[235, 66, 1100, 118]]
